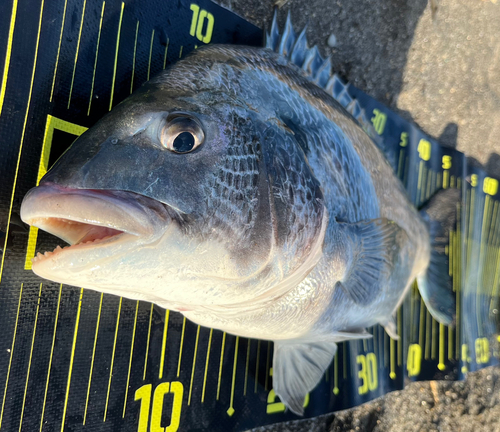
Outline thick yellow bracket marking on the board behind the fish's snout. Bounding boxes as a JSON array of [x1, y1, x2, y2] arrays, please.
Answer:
[[24, 114, 87, 270]]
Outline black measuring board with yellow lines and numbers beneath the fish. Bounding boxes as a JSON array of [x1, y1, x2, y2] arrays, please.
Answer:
[[0, 0, 500, 432]]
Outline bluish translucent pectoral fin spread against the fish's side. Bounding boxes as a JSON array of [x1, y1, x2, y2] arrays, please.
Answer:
[[338, 218, 406, 306]]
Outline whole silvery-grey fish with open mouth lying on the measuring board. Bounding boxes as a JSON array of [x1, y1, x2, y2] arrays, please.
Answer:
[[21, 15, 457, 415]]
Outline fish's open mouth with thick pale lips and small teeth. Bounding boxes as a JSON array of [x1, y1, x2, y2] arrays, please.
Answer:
[[21, 184, 170, 266]]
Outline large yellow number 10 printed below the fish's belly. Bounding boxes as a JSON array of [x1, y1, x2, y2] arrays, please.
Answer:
[[134, 381, 184, 432]]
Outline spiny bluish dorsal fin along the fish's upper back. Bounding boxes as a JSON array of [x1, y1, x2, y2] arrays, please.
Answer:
[[265, 9, 378, 145]]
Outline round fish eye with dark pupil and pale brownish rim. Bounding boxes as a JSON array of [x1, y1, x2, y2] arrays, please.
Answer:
[[159, 115, 205, 153]]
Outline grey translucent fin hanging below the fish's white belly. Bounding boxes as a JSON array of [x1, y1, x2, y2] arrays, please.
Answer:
[[273, 341, 337, 415]]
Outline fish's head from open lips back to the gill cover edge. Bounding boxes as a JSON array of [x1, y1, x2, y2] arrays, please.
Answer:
[[21, 50, 326, 311]]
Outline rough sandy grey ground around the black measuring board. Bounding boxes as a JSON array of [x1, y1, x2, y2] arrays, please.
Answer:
[[212, 0, 500, 432]]
